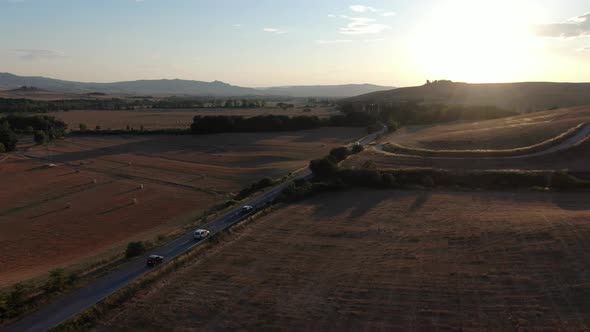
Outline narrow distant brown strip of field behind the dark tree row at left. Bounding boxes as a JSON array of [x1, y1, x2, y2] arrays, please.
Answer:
[[47, 107, 339, 130]]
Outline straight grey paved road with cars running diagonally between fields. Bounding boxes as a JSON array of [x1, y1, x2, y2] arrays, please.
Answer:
[[0, 127, 387, 332]]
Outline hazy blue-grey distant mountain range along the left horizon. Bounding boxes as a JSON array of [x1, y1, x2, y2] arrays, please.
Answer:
[[0, 73, 393, 98]]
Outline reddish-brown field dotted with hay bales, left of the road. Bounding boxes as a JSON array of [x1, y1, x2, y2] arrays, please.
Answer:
[[0, 128, 364, 288]]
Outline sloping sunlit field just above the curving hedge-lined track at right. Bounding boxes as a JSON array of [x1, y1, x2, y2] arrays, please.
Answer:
[[383, 106, 590, 150]]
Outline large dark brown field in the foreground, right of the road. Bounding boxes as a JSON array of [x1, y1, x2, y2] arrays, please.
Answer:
[[96, 190, 590, 331]]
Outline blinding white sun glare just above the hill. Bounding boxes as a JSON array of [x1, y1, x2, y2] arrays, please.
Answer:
[[412, 0, 540, 82]]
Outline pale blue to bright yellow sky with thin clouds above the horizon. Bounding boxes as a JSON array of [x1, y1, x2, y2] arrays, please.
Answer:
[[0, 0, 590, 87]]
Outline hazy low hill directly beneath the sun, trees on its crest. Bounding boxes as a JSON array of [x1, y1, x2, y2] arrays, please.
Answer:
[[342, 81, 590, 112]]
